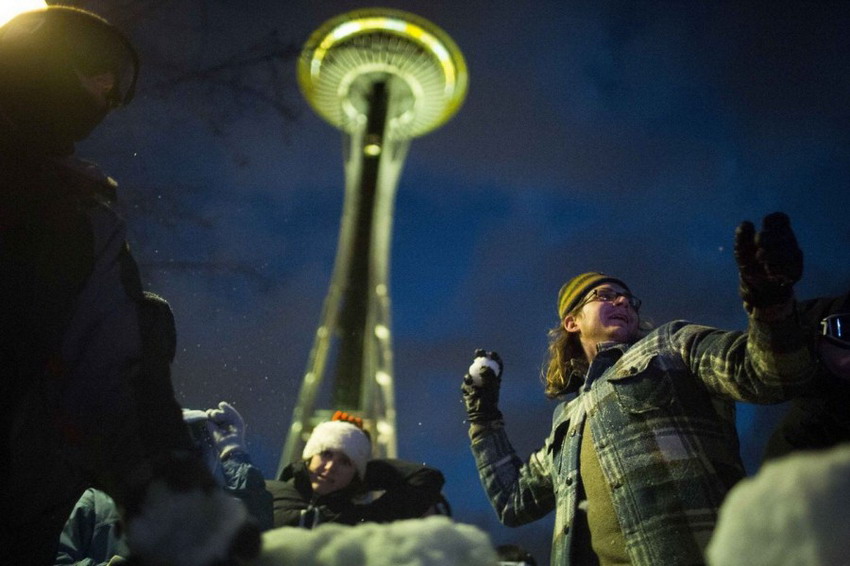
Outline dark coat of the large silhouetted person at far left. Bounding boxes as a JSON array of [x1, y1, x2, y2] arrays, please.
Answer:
[[0, 136, 197, 566]]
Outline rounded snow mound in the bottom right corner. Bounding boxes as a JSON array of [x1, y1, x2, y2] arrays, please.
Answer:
[[708, 444, 850, 566]]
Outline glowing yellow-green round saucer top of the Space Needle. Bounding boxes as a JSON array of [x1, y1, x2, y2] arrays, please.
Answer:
[[298, 8, 468, 139]]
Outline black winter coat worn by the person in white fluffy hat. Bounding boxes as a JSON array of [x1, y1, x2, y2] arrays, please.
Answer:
[[266, 459, 445, 528]]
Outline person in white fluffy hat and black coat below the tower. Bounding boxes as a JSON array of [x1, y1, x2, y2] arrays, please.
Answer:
[[266, 411, 444, 529]]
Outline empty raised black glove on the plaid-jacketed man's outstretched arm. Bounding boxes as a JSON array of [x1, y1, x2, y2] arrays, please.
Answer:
[[735, 212, 803, 310]]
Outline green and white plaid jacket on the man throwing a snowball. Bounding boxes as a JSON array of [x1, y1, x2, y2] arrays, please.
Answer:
[[472, 319, 814, 566]]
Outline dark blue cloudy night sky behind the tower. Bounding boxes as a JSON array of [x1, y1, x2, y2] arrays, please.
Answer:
[[71, 0, 850, 564]]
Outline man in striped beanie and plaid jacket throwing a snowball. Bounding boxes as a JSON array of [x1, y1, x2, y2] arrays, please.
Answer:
[[462, 213, 814, 566]]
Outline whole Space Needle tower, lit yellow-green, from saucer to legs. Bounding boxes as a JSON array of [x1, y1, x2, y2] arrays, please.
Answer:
[[278, 9, 467, 476]]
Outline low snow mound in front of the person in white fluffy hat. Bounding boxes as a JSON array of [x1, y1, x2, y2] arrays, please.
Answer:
[[251, 516, 499, 566]]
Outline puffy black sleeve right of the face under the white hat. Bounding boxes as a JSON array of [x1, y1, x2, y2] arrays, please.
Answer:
[[357, 459, 445, 523]]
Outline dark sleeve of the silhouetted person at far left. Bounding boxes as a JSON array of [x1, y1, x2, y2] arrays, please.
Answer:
[[62, 206, 205, 507]]
